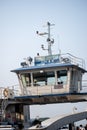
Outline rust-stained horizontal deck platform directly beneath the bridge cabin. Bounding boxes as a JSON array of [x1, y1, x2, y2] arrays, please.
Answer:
[[12, 92, 87, 105]]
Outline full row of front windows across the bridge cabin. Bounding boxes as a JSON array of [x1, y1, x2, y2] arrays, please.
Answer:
[[21, 70, 67, 86]]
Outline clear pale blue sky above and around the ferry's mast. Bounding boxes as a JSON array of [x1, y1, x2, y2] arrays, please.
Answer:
[[0, 0, 87, 121]]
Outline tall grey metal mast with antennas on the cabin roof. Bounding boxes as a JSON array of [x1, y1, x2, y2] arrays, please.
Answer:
[[36, 22, 54, 55]]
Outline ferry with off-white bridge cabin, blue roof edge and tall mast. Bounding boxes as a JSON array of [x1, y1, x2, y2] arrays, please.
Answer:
[[0, 22, 87, 128]]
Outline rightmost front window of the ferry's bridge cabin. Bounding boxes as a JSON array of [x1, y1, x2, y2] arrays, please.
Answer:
[[57, 70, 67, 84]]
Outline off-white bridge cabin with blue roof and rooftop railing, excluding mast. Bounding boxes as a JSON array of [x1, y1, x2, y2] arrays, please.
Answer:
[[12, 54, 86, 95]]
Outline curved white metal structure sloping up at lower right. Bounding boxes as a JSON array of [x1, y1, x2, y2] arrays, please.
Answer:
[[26, 111, 87, 130]]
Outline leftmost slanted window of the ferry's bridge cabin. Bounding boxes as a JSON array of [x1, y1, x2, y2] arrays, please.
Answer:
[[21, 74, 31, 87]]
